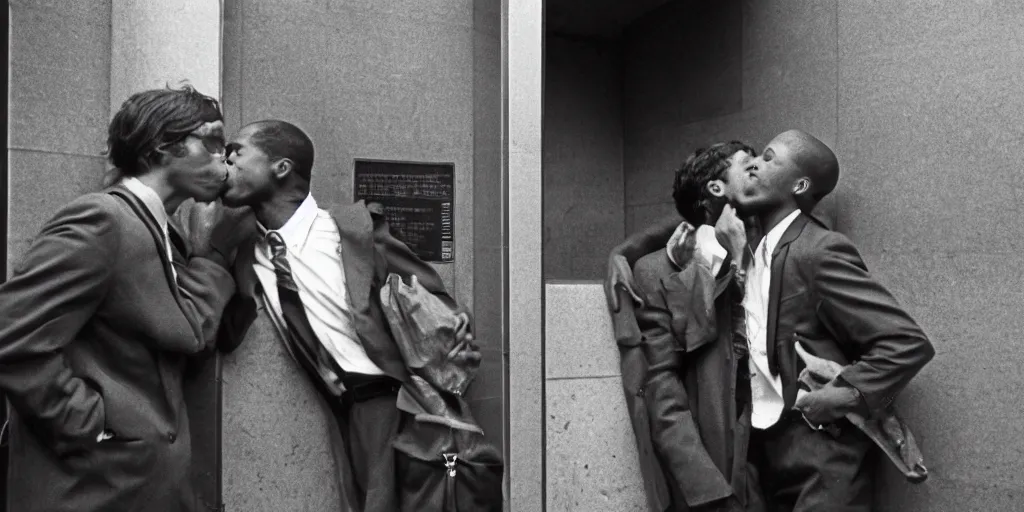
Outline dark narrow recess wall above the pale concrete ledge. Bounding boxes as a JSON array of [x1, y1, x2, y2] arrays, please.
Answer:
[[544, 35, 625, 280]]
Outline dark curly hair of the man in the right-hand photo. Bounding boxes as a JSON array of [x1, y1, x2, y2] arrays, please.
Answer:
[[672, 140, 756, 226]]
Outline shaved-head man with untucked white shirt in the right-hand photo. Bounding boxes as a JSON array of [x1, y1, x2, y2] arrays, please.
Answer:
[[733, 130, 935, 512]]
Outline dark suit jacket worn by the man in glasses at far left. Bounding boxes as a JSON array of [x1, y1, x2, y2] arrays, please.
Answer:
[[0, 186, 234, 512]]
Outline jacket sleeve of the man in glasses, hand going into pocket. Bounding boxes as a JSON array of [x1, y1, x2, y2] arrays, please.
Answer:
[[0, 195, 117, 455]]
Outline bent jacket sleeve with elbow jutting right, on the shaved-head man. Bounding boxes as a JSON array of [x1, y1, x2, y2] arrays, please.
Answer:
[[813, 232, 935, 415]]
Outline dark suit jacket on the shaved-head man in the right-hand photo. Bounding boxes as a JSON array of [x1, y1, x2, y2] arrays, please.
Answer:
[[766, 214, 935, 415]]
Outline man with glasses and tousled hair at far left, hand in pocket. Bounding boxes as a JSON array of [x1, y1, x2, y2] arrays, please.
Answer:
[[0, 87, 243, 512]]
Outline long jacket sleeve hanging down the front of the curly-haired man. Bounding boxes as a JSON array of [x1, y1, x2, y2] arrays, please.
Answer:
[[634, 253, 733, 507]]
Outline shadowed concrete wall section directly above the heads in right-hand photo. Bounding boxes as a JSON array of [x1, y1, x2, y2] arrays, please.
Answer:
[[623, 0, 836, 232]]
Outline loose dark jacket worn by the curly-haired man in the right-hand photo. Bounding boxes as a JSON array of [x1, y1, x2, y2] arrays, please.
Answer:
[[634, 249, 761, 511]]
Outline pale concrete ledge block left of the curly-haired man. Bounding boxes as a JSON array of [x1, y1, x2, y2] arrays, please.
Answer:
[[544, 281, 647, 512]]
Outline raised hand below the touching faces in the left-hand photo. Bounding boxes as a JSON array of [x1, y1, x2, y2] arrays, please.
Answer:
[[188, 201, 255, 265]]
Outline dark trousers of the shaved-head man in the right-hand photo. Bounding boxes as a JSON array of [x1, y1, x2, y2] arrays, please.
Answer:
[[749, 411, 876, 512]]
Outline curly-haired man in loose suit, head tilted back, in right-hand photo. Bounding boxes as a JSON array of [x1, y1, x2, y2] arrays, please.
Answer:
[[633, 141, 764, 512]]
